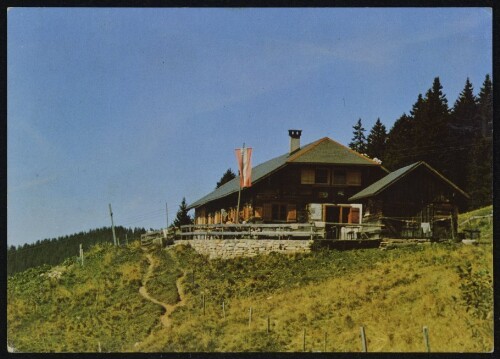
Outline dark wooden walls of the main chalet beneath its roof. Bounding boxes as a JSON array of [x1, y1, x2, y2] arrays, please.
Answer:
[[191, 139, 387, 224]]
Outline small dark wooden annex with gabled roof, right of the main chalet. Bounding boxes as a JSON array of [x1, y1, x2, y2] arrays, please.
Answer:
[[349, 161, 469, 238]]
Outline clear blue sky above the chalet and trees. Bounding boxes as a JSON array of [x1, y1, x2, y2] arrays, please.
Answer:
[[7, 8, 492, 245]]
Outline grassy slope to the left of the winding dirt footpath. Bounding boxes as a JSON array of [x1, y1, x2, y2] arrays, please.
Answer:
[[7, 242, 161, 352]]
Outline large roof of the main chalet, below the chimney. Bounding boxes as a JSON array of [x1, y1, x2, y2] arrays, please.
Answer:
[[187, 137, 383, 209]]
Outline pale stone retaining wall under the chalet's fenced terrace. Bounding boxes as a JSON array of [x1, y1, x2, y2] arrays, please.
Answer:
[[176, 239, 313, 259]]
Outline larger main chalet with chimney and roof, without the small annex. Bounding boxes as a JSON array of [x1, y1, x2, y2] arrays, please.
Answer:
[[188, 130, 387, 228]]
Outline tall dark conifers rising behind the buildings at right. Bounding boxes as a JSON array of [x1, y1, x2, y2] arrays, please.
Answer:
[[349, 75, 493, 210]]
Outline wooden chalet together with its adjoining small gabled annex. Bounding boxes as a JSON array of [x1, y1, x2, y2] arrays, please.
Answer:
[[188, 130, 469, 238]]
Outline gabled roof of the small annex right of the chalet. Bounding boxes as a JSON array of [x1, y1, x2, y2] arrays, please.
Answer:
[[349, 161, 470, 202]]
